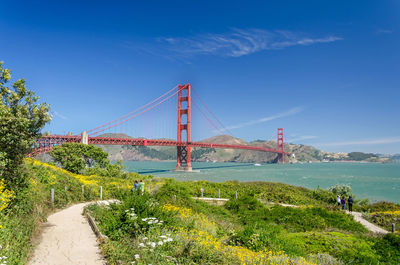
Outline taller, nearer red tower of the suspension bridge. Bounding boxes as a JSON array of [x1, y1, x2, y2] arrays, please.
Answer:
[[176, 83, 192, 171]]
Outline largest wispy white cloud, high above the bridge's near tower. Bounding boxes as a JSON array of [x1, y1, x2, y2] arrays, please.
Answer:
[[158, 29, 342, 57]]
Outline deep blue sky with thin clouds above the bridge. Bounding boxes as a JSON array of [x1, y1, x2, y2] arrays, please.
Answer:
[[0, 0, 400, 153]]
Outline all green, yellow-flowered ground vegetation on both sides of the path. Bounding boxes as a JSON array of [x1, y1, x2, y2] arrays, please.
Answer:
[[0, 159, 400, 264]]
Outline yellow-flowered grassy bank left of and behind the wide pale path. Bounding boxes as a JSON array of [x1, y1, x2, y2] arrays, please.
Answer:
[[0, 159, 145, 264]]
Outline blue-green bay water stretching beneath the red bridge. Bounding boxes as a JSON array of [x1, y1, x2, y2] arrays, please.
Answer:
[[125, 161, 400, 203]]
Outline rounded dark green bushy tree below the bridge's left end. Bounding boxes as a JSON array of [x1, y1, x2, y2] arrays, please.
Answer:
[[50, 143, 110, 173]]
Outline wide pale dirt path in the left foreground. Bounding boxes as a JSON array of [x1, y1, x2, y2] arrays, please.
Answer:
[[28, 202, 105, 265]]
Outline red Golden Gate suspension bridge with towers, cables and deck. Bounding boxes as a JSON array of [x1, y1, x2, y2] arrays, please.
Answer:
[[30, 83, 290, 171]]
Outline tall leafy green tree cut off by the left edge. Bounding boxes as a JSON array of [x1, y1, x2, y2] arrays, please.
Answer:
[[0, 62, 50, 188]]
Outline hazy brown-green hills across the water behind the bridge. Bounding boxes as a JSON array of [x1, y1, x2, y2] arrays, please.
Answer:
[[95, 134, 358, 163]]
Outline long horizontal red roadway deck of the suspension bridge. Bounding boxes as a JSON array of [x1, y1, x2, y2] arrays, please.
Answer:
[[31, 135, 291, 155]]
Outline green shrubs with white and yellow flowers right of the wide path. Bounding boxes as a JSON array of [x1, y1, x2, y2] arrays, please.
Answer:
[[86, 180, 400, 264]]
